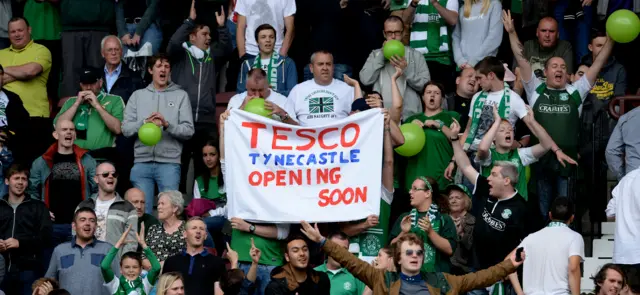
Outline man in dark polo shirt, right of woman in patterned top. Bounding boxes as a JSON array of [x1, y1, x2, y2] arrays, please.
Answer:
[[162, 217, 227, 295]]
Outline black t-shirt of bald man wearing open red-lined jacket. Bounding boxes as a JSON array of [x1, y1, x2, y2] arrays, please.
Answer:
[[49, 153, 83, 224]]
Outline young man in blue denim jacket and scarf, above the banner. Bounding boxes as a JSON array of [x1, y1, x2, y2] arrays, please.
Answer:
[[237, 24, 298, 96]]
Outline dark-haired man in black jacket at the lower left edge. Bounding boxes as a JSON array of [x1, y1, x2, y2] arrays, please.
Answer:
[[0, 164, 51, 294]]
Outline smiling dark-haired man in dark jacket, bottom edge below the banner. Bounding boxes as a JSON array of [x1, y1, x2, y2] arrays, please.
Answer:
[[265, 236, 331, 295]]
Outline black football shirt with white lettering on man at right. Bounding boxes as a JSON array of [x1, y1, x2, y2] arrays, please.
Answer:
[[473, 175, 533, 269]]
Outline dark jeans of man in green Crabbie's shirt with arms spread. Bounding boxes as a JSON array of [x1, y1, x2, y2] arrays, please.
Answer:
[[532, 161, 575, 221]]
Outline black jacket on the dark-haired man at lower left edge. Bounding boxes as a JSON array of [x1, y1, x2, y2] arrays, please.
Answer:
[[0, 194, 53, 272]]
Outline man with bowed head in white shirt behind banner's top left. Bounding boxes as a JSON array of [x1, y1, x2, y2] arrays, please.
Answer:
[[227, 69, 298, 125]]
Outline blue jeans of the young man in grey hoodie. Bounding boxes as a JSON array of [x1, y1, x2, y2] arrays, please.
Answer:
[[130, 162, 180, 214]]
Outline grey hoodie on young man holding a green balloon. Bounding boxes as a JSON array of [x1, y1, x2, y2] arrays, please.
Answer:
[[122, 83, 194, 164]]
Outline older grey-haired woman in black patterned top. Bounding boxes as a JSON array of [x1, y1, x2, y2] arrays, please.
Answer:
[[142, 191, 185, 270]]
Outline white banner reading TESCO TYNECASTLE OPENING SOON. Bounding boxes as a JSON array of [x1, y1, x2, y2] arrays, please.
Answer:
[[224, 109, 384, 223]]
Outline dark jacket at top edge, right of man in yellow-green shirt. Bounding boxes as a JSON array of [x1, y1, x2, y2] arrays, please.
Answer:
[[60, 0, 116, 32]]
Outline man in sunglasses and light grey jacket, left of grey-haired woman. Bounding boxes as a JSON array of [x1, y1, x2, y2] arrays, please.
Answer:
[[78, 162, 138, 260]]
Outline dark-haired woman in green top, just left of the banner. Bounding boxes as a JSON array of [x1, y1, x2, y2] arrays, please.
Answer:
[[187, 139, 227, 253]]
